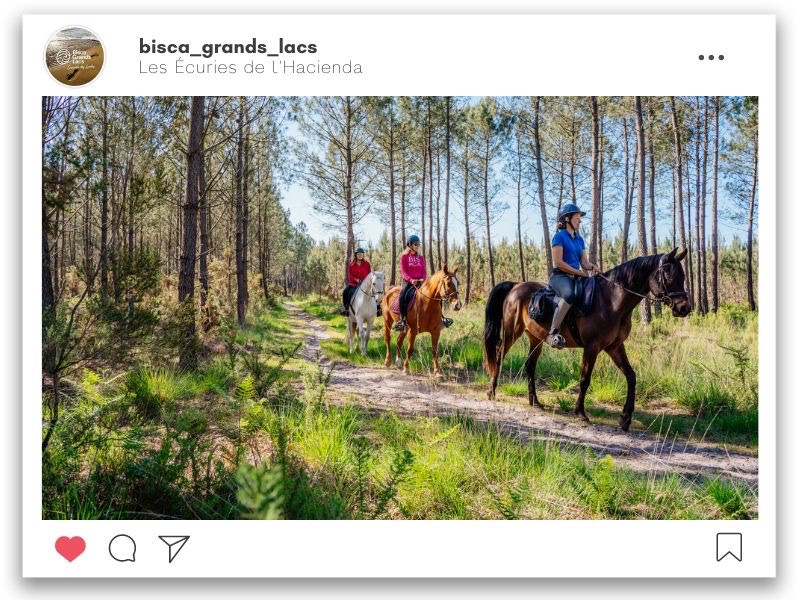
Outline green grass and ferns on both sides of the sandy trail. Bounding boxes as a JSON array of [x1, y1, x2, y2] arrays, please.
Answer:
[[42, 300, 758, 519]]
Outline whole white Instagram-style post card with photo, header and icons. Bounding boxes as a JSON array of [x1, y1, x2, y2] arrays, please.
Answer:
[[22, 15, 776, 578]]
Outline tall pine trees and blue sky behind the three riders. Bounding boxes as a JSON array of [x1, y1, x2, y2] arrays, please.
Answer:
[[42, 96, 758, 358]]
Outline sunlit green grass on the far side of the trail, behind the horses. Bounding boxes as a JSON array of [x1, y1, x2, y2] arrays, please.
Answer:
[[296, 297, 758, 448]]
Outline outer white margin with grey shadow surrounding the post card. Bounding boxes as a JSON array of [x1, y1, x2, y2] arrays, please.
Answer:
[[0, 2, 798, 597]]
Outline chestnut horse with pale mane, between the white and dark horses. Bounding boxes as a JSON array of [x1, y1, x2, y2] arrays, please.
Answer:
[[381, 265, 461, 377]]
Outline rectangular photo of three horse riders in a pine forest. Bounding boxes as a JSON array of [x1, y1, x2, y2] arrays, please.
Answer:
[[40, 95, 760, 527]]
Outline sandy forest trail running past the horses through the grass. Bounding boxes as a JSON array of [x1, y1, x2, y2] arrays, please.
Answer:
[[286, 304, 758, 488]]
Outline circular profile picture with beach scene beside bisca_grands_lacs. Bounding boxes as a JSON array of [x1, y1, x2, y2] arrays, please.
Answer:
[[45, 27, 105, 86]]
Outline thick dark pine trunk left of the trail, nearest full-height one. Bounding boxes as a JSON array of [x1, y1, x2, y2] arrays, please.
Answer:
[[178, 96, 205, 370]]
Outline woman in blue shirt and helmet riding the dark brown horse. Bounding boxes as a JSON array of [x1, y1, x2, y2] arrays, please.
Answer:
[[547, 204, 597, 348]]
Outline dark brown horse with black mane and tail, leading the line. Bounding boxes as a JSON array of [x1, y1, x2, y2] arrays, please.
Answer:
[[483, 248, 691, 431]]
